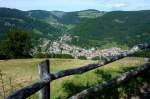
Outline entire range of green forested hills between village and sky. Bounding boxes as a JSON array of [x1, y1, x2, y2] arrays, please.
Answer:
[[0, 8, 150, 48]]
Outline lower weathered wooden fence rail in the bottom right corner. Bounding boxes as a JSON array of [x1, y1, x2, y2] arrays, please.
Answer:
[[69, 59, 150, 99]]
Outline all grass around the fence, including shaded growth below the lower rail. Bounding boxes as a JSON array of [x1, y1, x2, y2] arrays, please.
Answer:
[[0, 57, 147, 99]]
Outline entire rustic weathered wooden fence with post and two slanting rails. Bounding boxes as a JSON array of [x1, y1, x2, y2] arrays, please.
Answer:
[[6, 43, 150, 99]]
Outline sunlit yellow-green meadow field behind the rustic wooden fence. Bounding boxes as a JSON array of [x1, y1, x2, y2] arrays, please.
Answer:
[[0, 57, 149, 99]]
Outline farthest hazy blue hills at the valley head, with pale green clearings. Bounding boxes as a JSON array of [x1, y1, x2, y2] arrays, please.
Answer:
[[27, 9, 105, 26]]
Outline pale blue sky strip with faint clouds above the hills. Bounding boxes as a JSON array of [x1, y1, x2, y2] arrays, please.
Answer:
[[0, 0, 150, 11]]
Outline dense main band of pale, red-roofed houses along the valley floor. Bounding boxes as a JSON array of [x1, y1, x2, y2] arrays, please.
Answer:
[[48, 41, 122, 59]]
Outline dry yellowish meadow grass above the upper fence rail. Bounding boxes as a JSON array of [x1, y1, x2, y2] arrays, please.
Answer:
[[0, 59, 94, 96]]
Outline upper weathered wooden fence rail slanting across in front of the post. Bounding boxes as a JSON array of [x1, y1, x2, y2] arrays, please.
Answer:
[[6, 43, 150, 99]]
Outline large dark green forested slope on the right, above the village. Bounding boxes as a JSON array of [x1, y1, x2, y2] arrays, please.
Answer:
[[68, 11, 150, 47]]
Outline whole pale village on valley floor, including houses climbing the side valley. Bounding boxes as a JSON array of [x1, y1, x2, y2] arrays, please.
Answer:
[[36, 35, 123, 59]]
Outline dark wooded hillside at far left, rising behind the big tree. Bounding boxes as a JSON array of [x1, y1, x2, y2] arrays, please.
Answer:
[[0, 8, 60, 39]]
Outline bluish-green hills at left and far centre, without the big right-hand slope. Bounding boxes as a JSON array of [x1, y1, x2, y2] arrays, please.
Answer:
[[0, 8, 104, 40]]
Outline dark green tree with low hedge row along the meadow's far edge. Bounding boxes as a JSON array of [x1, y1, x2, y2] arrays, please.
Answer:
[[0, 29, 86, 59]]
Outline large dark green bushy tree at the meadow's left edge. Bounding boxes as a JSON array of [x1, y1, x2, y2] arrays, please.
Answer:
[[0, 29, 32, 59]]
